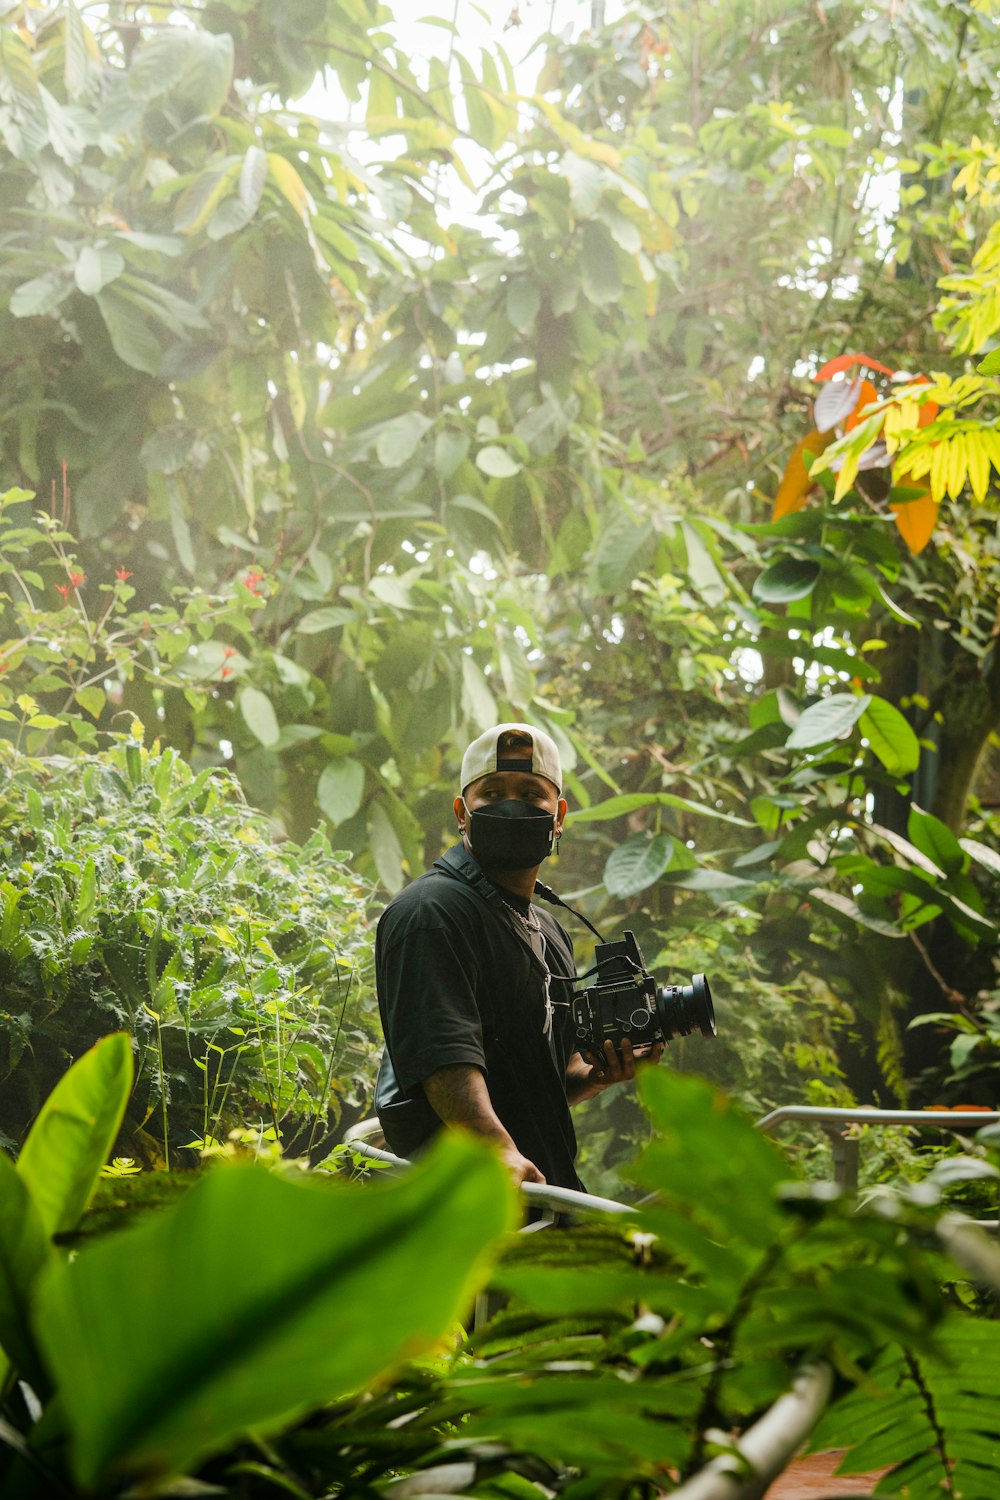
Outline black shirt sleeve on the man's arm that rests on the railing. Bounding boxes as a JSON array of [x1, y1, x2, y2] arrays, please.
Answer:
[[375, 906, 487, 1092]]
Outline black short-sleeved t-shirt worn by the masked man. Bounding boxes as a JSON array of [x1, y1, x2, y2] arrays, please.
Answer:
[[375, 845, 580, 1188]]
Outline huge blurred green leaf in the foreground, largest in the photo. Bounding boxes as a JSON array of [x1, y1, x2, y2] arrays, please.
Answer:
[[37, 1134, 513, 1485]]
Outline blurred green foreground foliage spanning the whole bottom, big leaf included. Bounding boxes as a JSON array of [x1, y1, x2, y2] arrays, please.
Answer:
[[0, 1049, 1000, 1500]]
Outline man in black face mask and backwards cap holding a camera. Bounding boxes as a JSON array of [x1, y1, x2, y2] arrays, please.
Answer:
[[375, 725, 663, 1188]]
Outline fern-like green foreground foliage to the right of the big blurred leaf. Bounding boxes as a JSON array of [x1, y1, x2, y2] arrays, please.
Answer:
[[167, 1073, 997, 1500]]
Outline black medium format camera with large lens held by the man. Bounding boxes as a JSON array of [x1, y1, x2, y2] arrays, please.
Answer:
[[570, 932, 715, 1058]]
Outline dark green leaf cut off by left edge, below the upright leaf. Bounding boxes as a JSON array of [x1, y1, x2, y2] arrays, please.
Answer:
[[0, 1151, 55, 1392]]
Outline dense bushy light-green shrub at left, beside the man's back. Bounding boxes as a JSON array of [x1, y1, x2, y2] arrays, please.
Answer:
[[0, 737, 379, 1164]]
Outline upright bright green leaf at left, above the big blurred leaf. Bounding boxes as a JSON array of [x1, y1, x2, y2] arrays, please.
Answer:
[[18, 1032, 132, 1235]]
